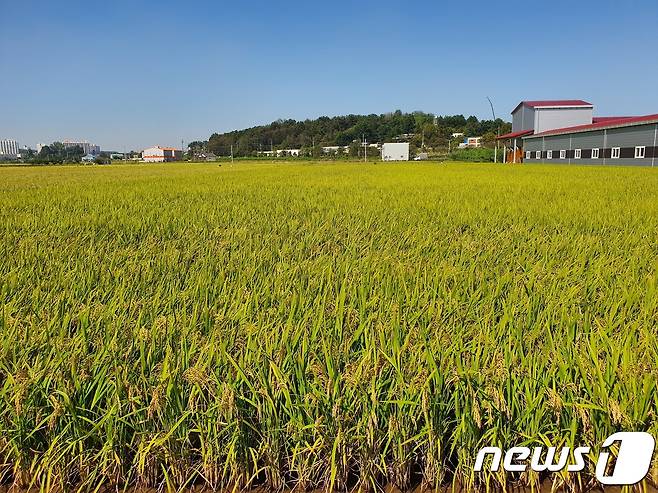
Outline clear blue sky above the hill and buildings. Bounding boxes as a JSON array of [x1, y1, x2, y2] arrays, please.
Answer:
[[0, 0, 658, 150]]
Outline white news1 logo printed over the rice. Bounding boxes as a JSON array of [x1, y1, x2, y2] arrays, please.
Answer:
[[475, 431, 655, 486]]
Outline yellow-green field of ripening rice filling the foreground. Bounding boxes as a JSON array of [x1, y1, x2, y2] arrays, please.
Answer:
[[0, 162, 658, 491]]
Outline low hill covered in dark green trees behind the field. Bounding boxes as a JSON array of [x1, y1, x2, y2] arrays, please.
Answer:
[[189, 110, 511, 156]]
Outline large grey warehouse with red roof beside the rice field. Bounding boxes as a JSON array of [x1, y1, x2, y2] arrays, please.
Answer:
[[499, 100, 658, 166]]
